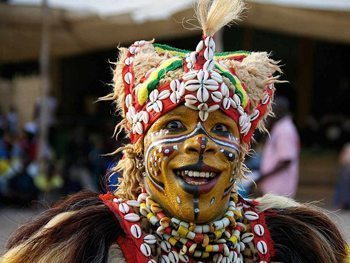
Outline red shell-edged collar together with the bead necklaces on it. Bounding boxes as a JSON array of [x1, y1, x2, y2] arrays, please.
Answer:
[[101, 193, 272, 263]]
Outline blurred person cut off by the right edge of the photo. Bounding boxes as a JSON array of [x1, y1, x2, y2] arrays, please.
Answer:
[[334, 143, 350, 209]]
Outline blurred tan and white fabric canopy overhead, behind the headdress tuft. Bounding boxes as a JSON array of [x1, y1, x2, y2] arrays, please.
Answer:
[[0, 0, 350, 62]]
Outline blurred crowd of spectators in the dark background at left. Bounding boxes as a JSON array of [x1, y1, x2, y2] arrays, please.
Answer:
[[0, 107, 115, 207]]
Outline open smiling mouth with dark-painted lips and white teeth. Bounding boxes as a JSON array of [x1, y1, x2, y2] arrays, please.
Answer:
[[173, 163, 222, 195]]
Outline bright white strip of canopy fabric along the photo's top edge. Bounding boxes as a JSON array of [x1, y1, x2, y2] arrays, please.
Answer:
[[10, 0, 350, 16]]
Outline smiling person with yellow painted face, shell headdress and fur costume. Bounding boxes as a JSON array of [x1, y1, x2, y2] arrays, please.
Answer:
[[2, 0, 346, 263]]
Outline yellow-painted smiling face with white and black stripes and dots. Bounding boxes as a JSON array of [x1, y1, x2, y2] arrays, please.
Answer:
[[144, 106, 239, 223]]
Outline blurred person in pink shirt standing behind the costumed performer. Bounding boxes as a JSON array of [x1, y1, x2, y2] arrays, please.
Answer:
[[257, 97, 300, 197]]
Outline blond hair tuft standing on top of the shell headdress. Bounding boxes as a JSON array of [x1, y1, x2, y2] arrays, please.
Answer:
[[195, 0, 245, 36]]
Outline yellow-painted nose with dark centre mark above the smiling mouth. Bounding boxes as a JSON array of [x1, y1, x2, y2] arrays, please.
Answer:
[[184, 135, 217, 155]]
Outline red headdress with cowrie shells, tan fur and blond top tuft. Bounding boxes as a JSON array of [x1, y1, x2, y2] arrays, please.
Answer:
[[102, 0, 280, 143]]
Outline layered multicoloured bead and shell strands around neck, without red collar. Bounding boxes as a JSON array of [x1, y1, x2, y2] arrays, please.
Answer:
[[123, 193, 256, 263]]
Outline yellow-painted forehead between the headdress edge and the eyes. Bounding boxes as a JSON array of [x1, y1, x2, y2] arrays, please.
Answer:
[[148, 106, 239, 136]]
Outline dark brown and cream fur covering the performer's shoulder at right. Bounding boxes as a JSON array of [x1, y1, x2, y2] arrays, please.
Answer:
[[257, 195, 346, 263]]
